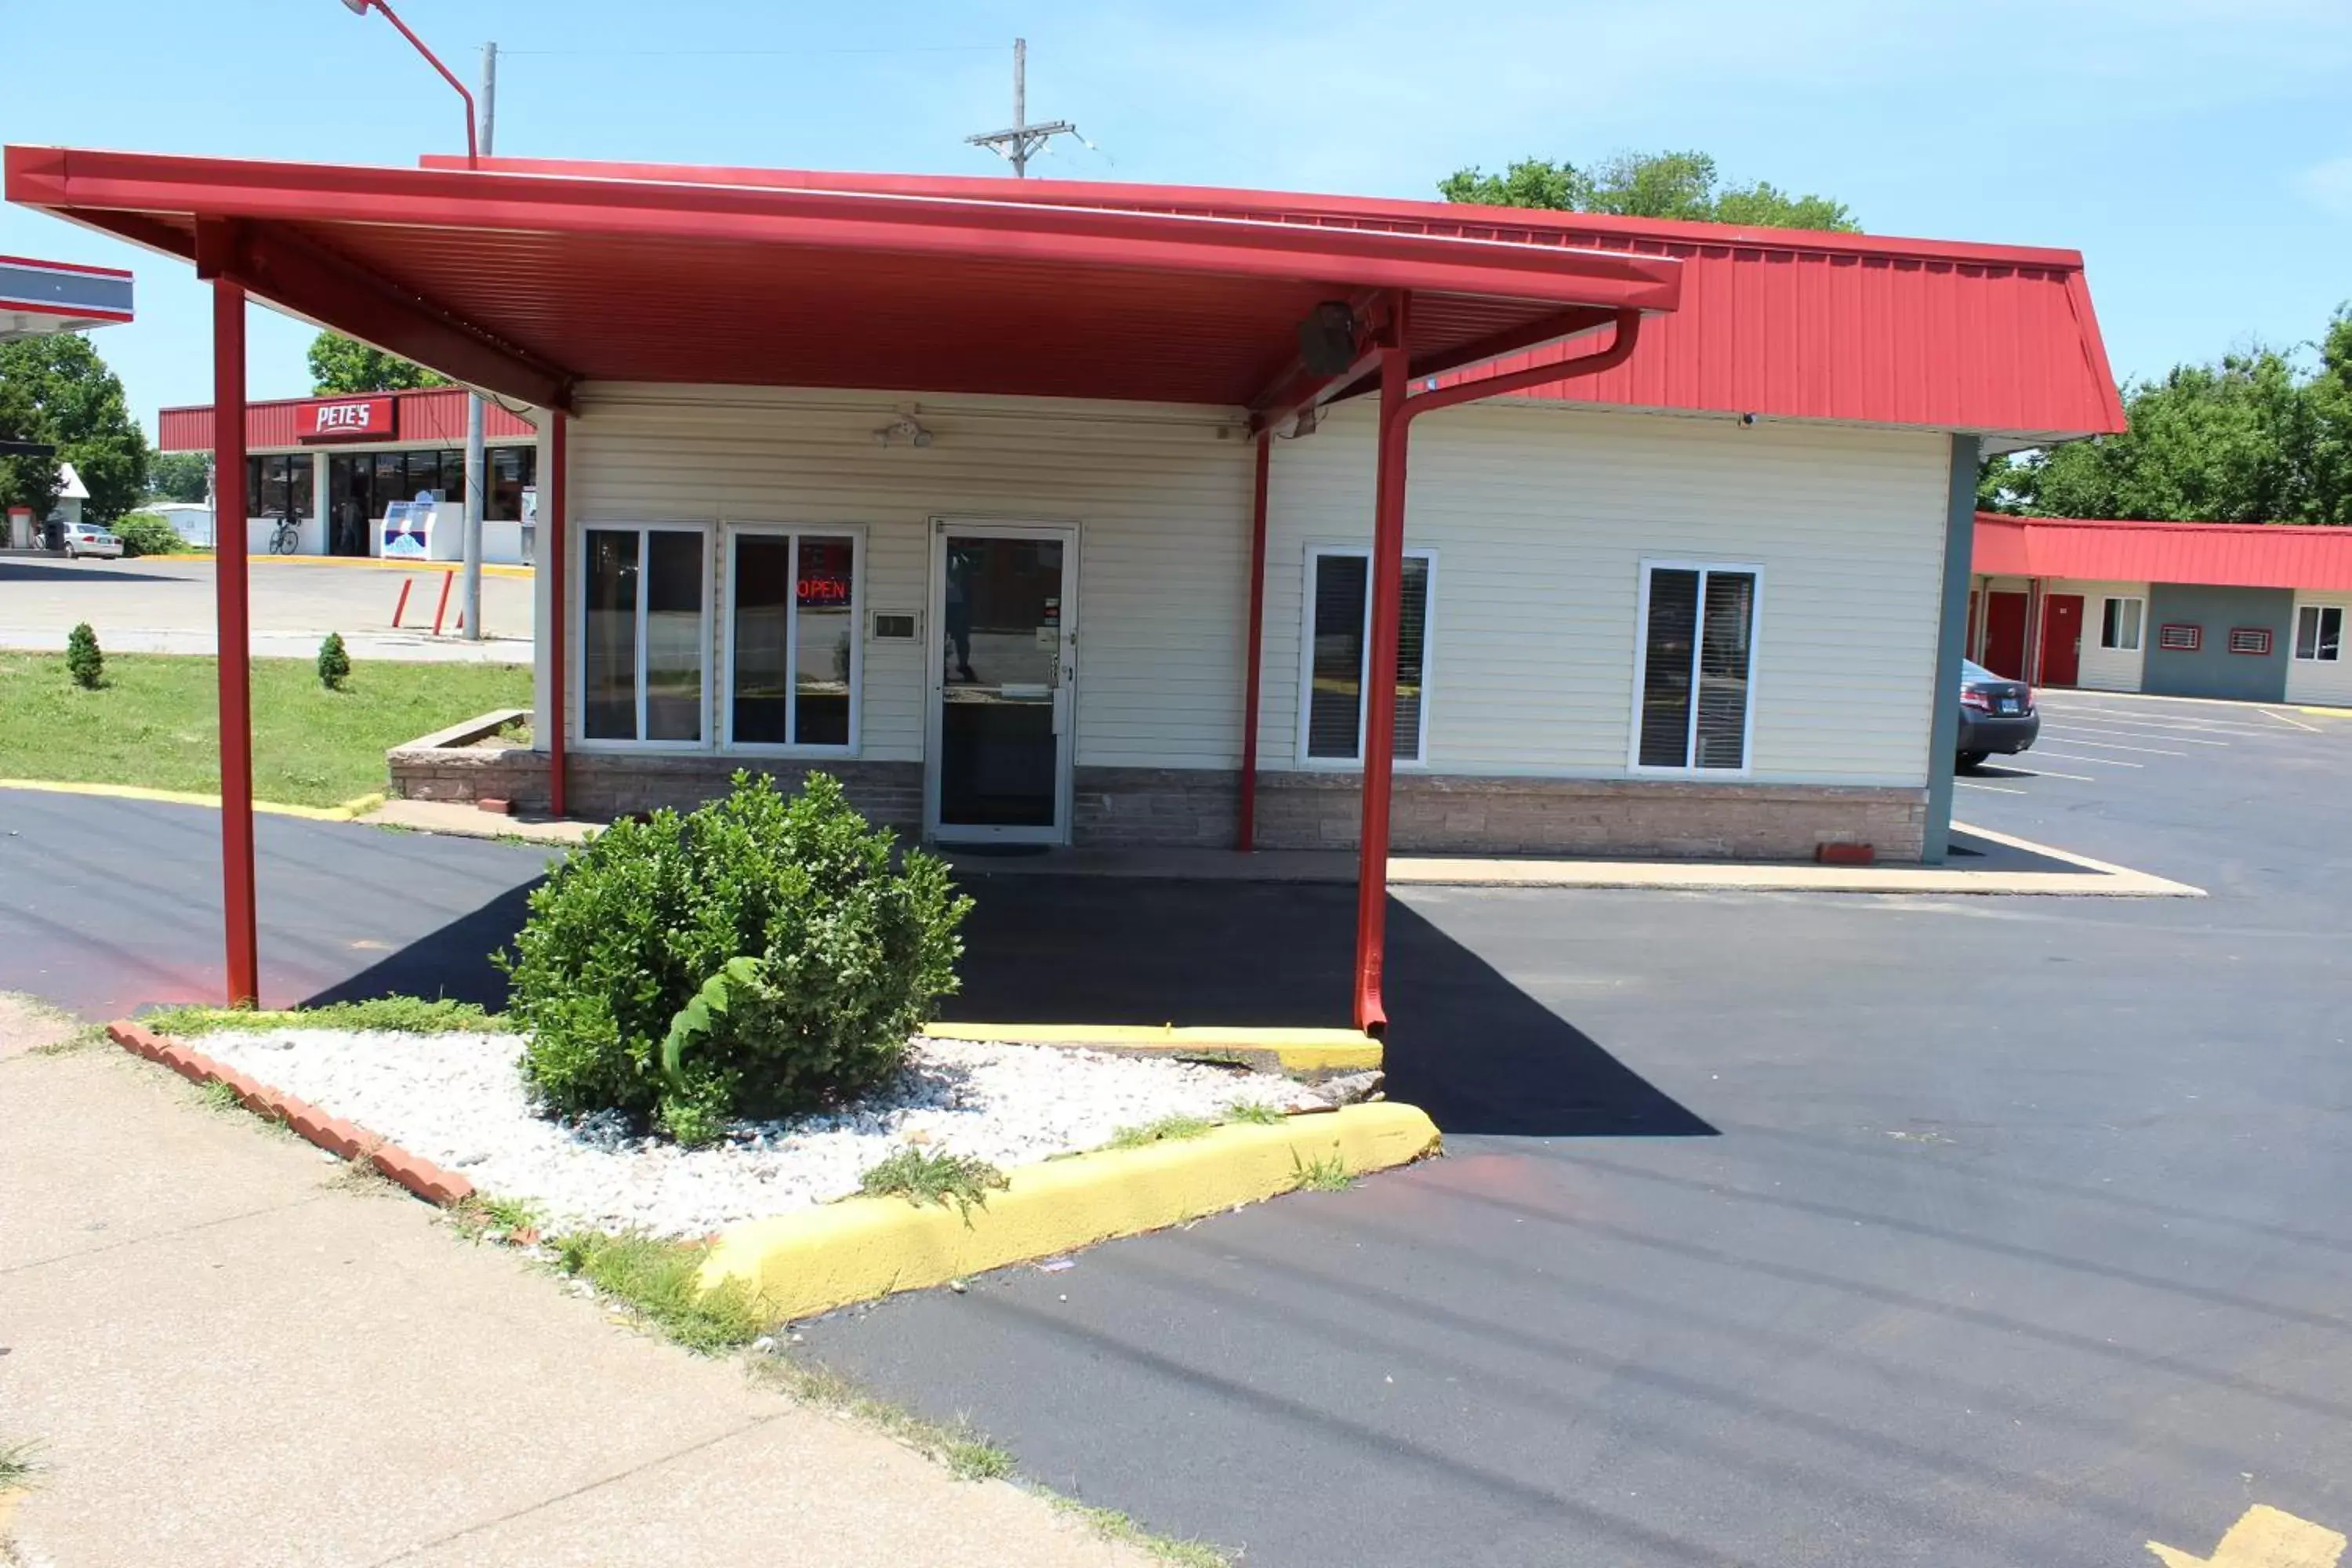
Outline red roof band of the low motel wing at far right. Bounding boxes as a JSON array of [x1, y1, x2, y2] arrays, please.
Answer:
[[1973, 513, 2352, 593]]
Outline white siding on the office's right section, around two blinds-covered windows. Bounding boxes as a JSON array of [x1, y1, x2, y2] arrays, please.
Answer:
[[1258, 400, 1950, 785]]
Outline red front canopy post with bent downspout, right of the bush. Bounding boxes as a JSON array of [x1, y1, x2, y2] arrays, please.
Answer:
[[1355, 310, 1642, 1034]]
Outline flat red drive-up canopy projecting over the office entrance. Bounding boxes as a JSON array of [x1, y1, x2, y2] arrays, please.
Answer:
[[7, 146, 1682, 407]]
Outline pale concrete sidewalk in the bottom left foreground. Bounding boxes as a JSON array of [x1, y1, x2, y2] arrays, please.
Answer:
[[0, 996, 1145, 1568]]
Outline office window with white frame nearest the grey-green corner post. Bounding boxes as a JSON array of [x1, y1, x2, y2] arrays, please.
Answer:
[[1632, 562, 1762, 771]]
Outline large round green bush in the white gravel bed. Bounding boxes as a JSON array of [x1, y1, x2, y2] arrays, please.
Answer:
[[499, 774, 971, 1142]]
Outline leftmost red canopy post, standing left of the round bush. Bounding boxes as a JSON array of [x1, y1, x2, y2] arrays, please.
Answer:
[[212, 278, 261, 1006]]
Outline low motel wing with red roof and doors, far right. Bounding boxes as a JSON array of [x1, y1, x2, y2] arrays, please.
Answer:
[[1969, 513, 2352, 708]]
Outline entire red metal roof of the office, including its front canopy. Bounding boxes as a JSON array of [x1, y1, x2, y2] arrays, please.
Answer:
[[7, 148, 2122, 440]]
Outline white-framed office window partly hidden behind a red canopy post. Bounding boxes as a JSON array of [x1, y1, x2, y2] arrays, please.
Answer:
[[1298, 546, 1437, 767]]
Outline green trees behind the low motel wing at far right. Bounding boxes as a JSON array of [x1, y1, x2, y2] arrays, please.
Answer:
[[1978, 306, 2352, 524]]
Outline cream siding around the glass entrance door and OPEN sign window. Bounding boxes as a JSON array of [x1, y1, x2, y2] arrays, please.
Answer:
[[569, 383, 1251, 769]]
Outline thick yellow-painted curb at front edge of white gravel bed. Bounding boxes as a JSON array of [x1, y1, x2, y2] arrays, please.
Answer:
[[701, 1102, 1439, 1321]]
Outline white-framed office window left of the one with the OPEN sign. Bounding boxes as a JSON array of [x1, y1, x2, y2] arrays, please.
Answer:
[[581, 524, 710, 746]]
